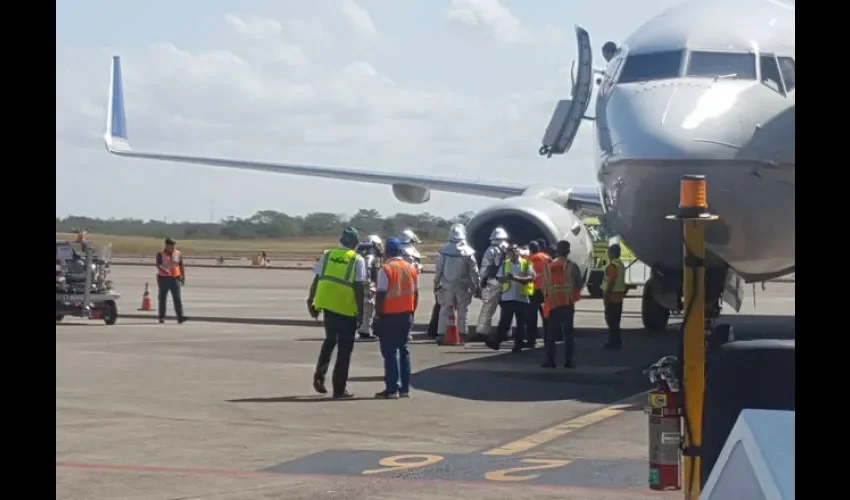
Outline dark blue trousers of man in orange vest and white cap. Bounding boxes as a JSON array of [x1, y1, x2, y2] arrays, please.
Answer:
[[378, 313, 413, 394]]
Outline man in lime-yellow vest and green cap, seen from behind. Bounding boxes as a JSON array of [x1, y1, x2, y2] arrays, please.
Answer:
[[307, 227, 369, 399]]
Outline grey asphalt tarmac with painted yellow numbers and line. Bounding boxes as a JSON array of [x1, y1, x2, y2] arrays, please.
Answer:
[[56, 266, 795, 500]]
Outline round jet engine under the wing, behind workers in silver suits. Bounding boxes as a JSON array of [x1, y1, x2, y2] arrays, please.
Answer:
[[466, 196, 593, 278]]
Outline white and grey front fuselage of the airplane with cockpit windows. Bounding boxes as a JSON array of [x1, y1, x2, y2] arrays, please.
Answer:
[[596, 0, 796, 281]]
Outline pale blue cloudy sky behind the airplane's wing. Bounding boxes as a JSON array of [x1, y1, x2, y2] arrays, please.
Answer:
[[56, 0, 680, 221]]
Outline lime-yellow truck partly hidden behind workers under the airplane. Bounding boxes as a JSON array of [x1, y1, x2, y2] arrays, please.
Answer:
[[583, 217, 650, 299]]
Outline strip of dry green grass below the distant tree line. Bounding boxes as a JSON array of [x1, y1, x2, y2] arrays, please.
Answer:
[[56, 233, 441, 260]]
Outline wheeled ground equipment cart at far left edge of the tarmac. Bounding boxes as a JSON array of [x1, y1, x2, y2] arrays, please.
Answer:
[[56, 238, 121, 325]]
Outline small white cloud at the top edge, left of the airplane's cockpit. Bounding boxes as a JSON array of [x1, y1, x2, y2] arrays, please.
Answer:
[[446, 0, 563, 44]]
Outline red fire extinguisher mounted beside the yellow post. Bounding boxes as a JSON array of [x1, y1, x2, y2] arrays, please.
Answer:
[[644, 356, 682, 491]]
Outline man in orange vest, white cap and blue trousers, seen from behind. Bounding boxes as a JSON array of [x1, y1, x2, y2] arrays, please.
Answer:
[[375, 238, 419, 399]]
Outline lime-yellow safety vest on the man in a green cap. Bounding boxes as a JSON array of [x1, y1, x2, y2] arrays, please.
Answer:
[[313, 248, 363, 317]]
